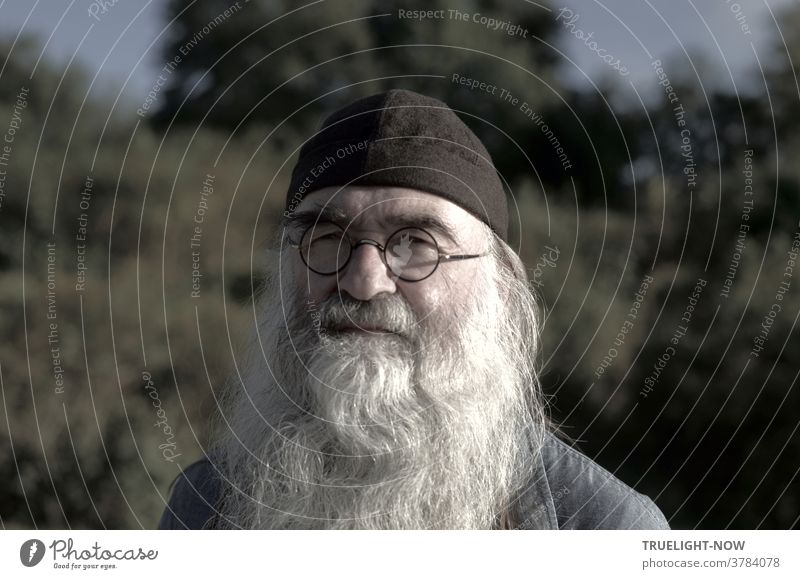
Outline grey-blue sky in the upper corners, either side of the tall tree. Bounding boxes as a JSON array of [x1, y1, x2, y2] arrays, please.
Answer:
[[0, 0, 793, 107]]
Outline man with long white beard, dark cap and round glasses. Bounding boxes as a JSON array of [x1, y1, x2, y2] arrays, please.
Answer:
[[160, 90, 669, 529]]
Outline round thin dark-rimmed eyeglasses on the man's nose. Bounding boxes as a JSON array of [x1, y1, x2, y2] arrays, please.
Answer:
[[290, 223, 489, 282]]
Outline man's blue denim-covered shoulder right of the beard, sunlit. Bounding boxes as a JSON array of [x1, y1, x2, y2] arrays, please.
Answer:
[[541, 434, 669, 529]]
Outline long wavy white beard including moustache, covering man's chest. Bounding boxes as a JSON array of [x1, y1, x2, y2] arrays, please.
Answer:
[[209, 242, 543, 529]]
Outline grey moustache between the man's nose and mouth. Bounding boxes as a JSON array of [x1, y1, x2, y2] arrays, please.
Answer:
[[320, 294, 420, 340]]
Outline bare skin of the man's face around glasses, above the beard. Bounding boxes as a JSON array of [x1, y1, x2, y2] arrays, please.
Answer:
[[290, 187, 489, 322]]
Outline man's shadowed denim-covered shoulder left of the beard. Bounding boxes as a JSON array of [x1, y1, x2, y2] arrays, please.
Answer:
[[158, 458, 220, 529]]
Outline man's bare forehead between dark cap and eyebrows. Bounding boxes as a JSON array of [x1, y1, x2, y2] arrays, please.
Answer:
[[296, 186, 481, 237]]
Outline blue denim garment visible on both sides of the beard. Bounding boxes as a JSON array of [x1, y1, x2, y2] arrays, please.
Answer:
[[158, 434, 669, 530]]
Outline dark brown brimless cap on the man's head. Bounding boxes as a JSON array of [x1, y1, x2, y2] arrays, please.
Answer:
[[286, 90, 508, 240]]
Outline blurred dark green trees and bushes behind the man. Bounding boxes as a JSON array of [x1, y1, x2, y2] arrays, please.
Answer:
[[0, 0, 800, 529]]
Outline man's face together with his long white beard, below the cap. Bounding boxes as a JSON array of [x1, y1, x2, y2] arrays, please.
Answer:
[[211, 187, 543, 529]]
